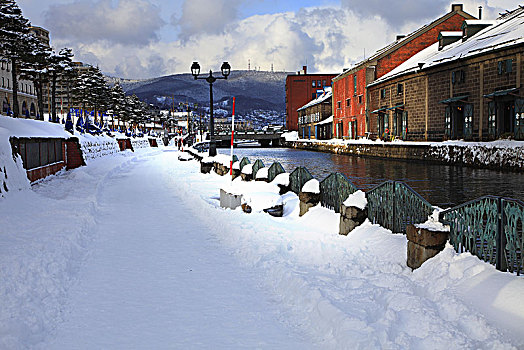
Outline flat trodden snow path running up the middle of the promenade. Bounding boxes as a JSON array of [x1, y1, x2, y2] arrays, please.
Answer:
[[43, 152, 312, 349]]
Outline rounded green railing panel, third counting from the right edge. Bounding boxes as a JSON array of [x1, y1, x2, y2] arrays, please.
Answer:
[[320, 173, 357, 213]]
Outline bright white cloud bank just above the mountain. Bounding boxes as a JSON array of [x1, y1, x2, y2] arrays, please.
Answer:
[[47, 0, 520, 78]]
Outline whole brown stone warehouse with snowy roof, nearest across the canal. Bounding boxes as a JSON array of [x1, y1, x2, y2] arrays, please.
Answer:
[[368, 8, 524, 141]]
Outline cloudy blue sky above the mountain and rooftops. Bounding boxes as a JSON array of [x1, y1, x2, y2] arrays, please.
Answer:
[[18, 0, 519, 79]]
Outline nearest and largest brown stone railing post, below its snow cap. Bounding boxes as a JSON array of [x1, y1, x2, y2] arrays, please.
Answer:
[[406, 225, 449, 270]]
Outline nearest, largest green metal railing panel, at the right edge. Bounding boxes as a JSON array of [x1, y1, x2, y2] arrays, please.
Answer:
[[441, 196, 524, 275]]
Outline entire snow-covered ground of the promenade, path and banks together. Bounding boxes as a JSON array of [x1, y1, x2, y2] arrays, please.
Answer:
[[0, 147, 524, 349]]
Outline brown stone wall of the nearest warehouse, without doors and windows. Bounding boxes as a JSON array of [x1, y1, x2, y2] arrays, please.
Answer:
[[368, 47, 524, 141]]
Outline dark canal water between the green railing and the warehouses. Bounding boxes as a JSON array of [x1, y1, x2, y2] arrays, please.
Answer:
[[218, 147, 524, 208]]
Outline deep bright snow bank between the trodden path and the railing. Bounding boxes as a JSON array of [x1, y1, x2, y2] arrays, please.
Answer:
[[167, 154, 524, 349]]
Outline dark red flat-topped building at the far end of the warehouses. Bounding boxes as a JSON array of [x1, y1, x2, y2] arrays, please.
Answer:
[[286, 66, 336, 131]]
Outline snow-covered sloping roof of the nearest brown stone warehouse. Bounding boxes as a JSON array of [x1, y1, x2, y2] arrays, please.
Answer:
[[368, 8, 524, 86]]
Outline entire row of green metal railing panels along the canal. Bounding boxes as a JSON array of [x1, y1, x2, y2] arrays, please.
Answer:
[[227, 153, 524, 275]]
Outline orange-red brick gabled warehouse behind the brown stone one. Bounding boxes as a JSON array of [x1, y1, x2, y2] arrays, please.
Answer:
[[333, 4, 474, 138]]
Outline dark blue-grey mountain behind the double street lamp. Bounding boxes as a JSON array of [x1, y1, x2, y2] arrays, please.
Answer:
[[108, 70, 290, 113]]
